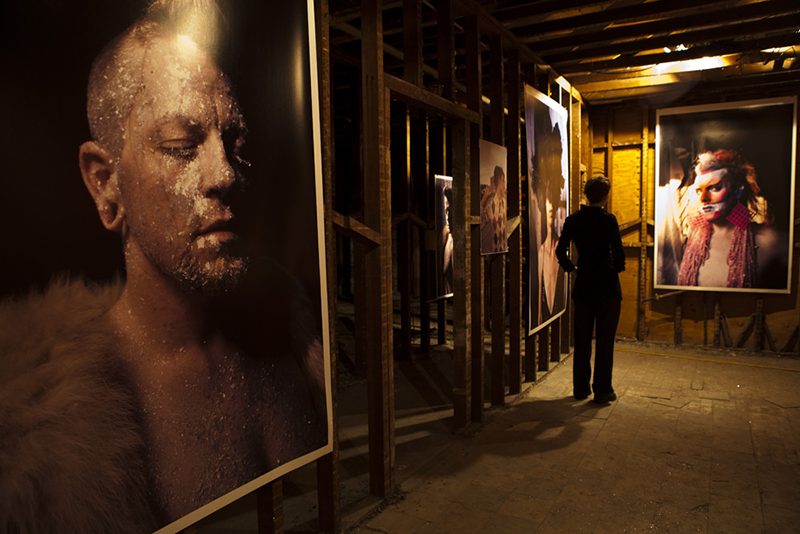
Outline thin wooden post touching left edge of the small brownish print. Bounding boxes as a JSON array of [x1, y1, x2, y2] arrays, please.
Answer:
[[462, 15, 484, 428]]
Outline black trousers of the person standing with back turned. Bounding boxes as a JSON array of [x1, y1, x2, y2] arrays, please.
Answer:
[[572, 296, 621, 397]]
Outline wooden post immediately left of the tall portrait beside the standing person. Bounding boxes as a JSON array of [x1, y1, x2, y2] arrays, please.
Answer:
[[506, 48, 524, 395]]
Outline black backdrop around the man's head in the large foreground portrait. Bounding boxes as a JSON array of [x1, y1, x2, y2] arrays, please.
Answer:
[[0, 0, 320, 326]]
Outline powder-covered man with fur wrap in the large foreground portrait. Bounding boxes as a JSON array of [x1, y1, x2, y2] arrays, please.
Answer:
[[0, 1, 328, 532]]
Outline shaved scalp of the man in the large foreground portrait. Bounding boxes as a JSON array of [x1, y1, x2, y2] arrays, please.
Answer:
[[86, 0, 222, 159]]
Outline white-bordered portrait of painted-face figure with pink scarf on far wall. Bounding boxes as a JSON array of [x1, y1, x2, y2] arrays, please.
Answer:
[[654, 97, 797, 293]]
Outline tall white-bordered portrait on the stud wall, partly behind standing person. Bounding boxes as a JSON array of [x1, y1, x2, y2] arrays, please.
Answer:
[[525, 85, 569, 334]]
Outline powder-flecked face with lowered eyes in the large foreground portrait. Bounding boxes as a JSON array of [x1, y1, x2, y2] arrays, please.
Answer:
[[117, 36, 247, 294]]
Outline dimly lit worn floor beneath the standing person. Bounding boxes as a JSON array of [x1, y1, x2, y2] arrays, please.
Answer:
[[354, 343, 800, 534]]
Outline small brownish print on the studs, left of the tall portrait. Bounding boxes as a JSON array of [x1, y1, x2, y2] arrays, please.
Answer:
[[480, 139, 508, 255]]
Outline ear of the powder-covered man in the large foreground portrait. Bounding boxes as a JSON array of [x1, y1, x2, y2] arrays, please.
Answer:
[[78, 141, 125, 232]]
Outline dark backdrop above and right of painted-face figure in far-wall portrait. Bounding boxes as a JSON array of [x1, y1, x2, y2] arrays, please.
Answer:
[[659, 104, 794, 230]]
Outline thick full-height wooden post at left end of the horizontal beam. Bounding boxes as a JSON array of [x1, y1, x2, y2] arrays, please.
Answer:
[[357, 0, 394, 497]]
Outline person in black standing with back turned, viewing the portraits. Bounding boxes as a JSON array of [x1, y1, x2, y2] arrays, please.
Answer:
[[556, 176, 625, 404]]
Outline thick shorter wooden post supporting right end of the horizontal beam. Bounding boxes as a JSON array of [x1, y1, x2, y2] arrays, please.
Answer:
[[450, 120, 474, 428]]
